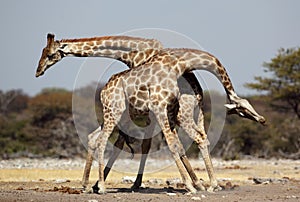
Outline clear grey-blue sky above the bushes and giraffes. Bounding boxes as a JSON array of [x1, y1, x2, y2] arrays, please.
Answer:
[[0, 0, 300, 95]]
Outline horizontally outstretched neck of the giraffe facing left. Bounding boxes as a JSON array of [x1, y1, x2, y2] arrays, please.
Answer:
[[58, 36, 162, 68]]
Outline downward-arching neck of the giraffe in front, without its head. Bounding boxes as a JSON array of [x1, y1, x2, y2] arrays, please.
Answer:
[[166, 49, 240, 102]]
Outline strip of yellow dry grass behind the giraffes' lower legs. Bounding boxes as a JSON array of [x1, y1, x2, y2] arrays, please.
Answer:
[[0, 160, 300, 182]]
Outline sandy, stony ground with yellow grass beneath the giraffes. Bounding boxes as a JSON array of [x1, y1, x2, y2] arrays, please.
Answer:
[[0, 159, 300, 202]]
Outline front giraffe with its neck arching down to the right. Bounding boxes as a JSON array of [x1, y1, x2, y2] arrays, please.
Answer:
[[79, 49, 265, 193]]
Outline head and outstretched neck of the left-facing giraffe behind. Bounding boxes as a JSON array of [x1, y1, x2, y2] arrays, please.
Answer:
[[36, 33, 206, 192]]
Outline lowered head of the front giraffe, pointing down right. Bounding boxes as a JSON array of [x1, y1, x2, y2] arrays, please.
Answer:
[[225, 98, 266, 125]]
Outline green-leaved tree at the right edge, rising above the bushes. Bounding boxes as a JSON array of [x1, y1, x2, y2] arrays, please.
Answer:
[[246, 48, 300, 119]]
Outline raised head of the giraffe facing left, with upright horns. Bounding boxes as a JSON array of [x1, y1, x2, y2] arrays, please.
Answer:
[[35, 34, 64, 77]]
